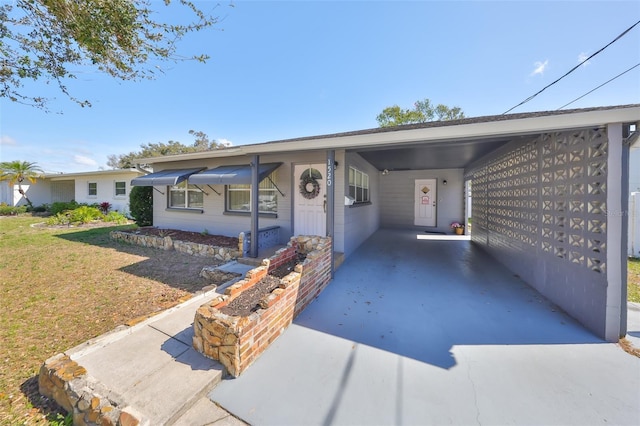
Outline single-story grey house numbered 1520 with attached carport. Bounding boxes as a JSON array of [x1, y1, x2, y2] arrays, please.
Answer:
[[132, 105, 640, 341]]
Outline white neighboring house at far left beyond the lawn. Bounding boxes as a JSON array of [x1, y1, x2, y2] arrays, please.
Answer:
[[14, 169, 143, 214]]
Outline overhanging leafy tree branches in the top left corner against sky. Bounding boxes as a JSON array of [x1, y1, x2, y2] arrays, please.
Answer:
[[0, 0, 218, 108]]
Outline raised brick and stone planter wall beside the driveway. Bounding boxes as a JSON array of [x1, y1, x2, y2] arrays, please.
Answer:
[[193, 236, 331, 377]]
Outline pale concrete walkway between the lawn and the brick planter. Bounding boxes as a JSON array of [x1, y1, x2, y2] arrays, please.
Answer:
[[66, 262, 251, 426]]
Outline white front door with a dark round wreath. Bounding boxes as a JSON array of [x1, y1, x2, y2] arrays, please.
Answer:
[[293, 163, 327, 237]]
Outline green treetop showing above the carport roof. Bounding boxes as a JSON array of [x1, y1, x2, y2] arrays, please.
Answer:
[[376, 98, 464, 127]]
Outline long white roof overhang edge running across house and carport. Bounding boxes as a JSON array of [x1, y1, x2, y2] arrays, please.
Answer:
[[134, 104, 640, 164]]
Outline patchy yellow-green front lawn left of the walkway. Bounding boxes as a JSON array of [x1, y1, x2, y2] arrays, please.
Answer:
[[0, 216, 218, 425]]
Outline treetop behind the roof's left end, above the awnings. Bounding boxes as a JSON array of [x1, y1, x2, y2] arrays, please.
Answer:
[[107, 130, 226, 169]]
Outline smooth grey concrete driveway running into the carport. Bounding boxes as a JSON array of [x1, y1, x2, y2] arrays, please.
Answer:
[[210, 230, 640, 425]]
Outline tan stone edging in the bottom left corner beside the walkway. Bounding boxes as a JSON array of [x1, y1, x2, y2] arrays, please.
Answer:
[[38, 354, 141, 426]]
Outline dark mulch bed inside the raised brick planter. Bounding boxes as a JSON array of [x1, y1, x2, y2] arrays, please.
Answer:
[[220, 254, 306, 317]]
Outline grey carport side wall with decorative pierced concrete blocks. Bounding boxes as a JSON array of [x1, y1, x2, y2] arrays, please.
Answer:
[[465, 128, 620, 339]]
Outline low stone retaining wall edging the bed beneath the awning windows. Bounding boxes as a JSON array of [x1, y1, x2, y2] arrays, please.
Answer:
[[109, 231, 242, 262]]
